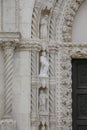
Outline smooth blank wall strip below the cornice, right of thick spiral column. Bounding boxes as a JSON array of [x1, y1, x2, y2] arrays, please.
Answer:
[[13, 51, 31, 130]]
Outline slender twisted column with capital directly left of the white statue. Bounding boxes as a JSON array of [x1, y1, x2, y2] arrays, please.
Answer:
[[31, 42, 40, 130]]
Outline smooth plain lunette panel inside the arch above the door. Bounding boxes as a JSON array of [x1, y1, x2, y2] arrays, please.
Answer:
[[72, 0, 87, 43]]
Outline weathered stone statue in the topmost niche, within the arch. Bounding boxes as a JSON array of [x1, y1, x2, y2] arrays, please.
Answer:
[[40, 15, 48, 39]]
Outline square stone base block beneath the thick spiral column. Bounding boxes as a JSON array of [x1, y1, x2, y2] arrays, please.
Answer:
[[0, 118, 16, 130]]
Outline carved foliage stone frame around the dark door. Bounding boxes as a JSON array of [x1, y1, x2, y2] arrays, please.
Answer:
[[57, 43, 87, 130]]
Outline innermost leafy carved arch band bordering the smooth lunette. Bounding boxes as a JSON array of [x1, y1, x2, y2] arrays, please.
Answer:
[[62, 0, 84, 42]]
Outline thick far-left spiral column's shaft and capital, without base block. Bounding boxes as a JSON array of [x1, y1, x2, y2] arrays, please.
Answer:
[[2, 42, 16, 115]]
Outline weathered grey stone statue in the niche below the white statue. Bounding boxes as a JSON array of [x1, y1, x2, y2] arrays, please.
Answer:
[[39, 90, 48, 113]]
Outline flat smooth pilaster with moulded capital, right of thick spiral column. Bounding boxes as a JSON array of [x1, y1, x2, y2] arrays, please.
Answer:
[[15, 41, 32, 130]]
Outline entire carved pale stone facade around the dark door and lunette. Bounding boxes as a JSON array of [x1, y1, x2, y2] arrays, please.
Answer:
[[0, 0, 87, 130]]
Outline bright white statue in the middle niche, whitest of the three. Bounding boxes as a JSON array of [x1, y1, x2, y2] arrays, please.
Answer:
[[40, 51, 49, 77]]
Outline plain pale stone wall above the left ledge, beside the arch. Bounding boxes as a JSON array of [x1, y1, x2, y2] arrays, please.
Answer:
[[0, 0, 34, 39]]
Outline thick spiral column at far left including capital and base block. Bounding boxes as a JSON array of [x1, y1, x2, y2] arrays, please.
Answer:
[[0, 41, 16, 130]]
